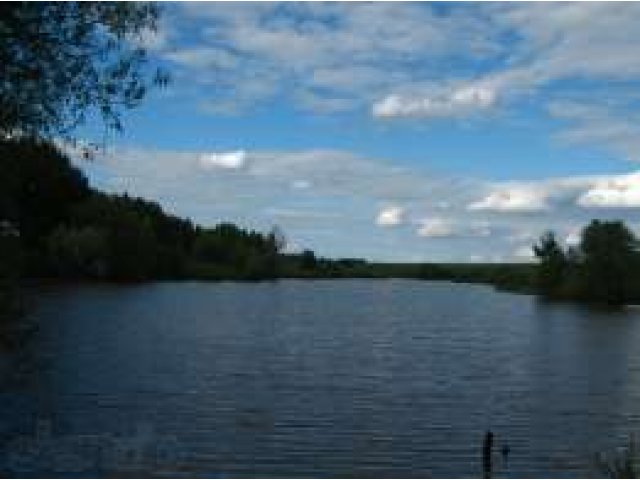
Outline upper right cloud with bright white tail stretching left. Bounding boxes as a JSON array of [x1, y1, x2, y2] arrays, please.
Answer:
[[362, 2, 640, 161]]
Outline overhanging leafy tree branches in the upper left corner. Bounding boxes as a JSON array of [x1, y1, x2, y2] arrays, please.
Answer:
[[0, 2, 168, 138]]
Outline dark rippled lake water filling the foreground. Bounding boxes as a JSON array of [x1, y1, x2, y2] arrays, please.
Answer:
[[0, 280, 640, 478]]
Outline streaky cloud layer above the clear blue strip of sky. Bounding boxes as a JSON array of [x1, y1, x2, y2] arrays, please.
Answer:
[[151, 2, 640, 160]]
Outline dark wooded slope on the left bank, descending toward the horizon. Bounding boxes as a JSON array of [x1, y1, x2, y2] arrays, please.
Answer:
[[0, 138, 285, 281]]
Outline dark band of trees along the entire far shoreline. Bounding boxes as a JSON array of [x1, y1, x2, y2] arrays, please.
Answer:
[[0, 139, 640, 304]]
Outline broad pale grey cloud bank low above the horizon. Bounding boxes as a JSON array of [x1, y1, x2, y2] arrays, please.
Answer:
[[69, 142, 640, 261]]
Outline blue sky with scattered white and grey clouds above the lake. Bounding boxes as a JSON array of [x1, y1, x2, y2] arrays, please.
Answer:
[[72, 2, 640, 262]]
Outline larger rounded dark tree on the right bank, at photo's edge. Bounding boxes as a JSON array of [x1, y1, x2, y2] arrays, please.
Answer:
[[580, 220, 638, 304]]
